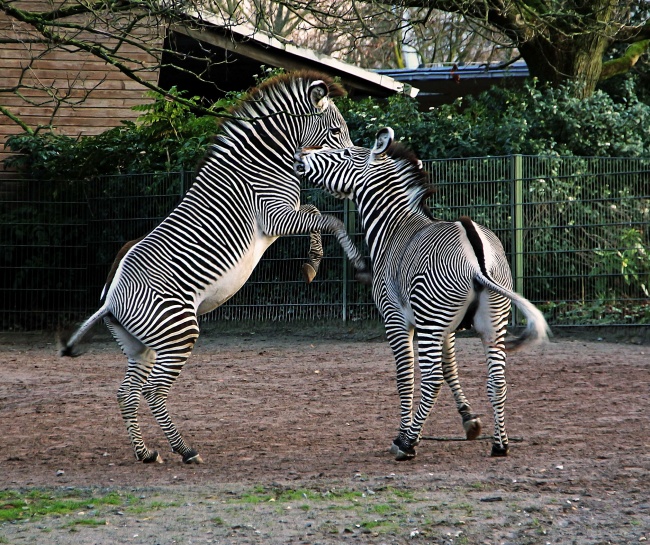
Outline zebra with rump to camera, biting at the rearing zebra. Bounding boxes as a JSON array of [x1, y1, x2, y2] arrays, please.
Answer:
[[294, 128, 548, 460]]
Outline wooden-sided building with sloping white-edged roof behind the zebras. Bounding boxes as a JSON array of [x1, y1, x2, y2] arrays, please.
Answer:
[[0, 6, 417, 177]]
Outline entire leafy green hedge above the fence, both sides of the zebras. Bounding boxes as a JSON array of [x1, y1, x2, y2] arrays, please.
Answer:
[[5, 77, 650, 180]]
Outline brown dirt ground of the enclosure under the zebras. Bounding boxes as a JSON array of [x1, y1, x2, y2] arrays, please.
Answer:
[[0, 320, 650, 545]]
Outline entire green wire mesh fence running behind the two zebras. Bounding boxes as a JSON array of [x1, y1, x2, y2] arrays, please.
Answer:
[[0, 155, 650, 331]]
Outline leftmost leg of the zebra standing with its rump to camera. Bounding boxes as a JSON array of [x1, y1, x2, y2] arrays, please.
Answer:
[[385, 315, 417, 461]]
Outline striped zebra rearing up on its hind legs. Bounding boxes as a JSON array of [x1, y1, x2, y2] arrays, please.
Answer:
[[61, 72, 365, 463]]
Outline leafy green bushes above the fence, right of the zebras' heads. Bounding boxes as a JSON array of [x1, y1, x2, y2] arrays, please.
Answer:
[[340, 81, 650, 159]]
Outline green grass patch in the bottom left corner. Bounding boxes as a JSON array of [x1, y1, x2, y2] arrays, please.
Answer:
[[0, 489, 124, 522]]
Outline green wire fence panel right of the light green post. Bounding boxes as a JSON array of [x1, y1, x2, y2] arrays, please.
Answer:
[[522, 157, 650, 325]]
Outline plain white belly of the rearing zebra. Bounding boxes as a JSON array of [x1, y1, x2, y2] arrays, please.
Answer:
[[196, 232, 278, 315]]
